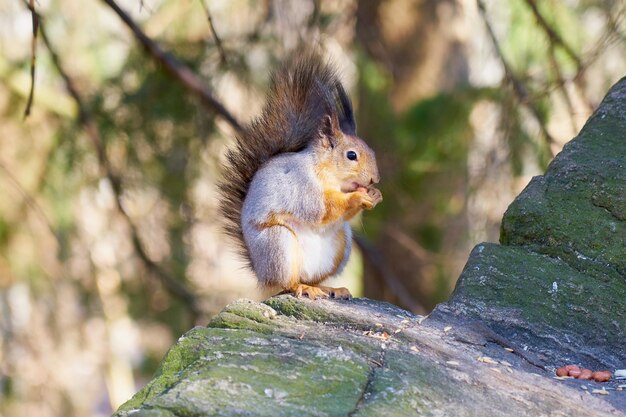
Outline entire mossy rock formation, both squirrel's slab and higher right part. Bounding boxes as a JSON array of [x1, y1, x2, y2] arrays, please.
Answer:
[[116, 79, 626, 417]]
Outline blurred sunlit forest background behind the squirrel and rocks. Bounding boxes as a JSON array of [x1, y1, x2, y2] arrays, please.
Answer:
[[0, 0, 626, 416]]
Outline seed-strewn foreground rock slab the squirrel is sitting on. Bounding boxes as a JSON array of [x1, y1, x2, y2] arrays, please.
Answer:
[[115, 295, 619, 417]]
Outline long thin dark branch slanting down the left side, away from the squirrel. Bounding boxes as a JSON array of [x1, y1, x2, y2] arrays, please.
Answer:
[[34, 12, 202, 321]]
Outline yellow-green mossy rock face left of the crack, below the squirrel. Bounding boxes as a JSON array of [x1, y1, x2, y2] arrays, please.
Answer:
[[118, 329, 369, 416]]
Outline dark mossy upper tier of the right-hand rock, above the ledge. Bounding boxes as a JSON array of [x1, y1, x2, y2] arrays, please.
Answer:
[[500, 76, 626, 276]]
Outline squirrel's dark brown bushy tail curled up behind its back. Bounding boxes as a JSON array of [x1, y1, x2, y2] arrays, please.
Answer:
[[219, 50, 356, 263]]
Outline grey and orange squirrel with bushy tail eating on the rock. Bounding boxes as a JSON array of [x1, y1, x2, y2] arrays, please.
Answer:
[[219, 50, 382, 299]]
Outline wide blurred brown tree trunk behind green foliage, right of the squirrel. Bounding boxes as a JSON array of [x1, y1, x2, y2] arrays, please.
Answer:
[[356, 0, 468, 309]]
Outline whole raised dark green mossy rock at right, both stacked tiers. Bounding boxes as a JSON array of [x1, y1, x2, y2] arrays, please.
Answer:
[[435, 78, 626, 369]]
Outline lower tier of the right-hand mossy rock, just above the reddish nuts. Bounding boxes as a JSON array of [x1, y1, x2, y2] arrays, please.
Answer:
[[433, 243, 626, 369]]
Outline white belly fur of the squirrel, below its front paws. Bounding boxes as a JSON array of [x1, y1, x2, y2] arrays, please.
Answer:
[[296, 223, 342, 284]]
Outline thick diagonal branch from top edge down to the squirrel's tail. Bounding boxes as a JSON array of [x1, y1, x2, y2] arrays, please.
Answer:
[[102, 0, 243, 132]]
